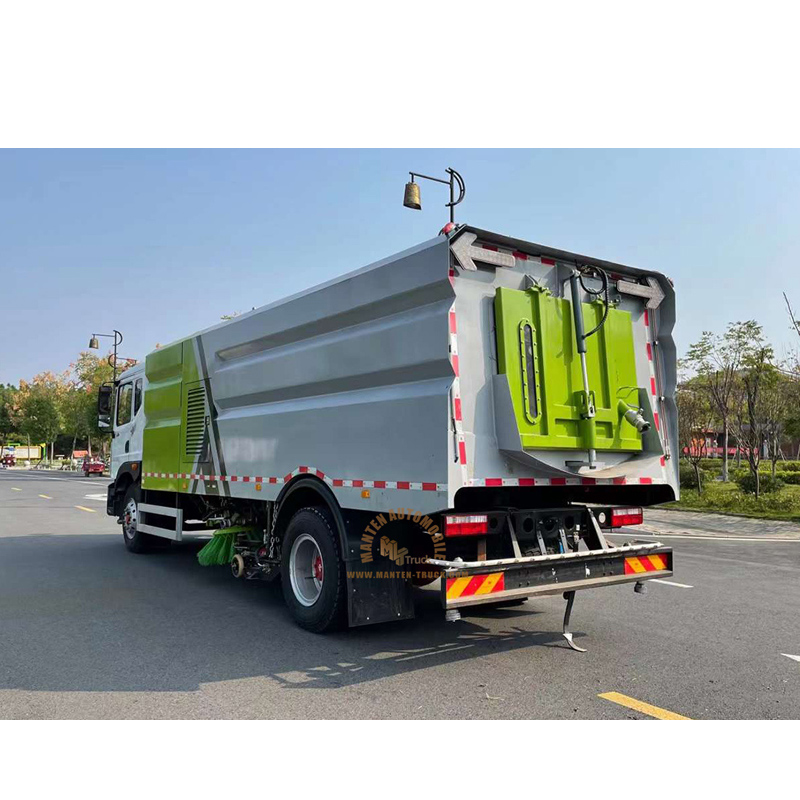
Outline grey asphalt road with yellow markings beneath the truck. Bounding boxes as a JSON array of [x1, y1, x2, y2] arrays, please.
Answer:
[[0, 470, 800, 719]]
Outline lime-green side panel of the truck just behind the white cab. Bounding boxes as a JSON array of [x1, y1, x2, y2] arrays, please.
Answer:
[[142, 339, 205, 492]]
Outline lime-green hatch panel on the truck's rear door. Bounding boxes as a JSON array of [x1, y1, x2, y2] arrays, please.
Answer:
[[495, 288, 642, 451]]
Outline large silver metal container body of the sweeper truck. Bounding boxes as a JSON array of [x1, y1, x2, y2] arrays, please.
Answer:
[[144, 226, 678, 513]]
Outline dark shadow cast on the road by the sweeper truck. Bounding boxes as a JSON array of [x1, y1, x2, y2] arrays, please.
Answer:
[[0, 534, 580, 692]]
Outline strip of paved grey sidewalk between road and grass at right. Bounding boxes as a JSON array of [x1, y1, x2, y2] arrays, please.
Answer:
[[637, 508, 800, 541]]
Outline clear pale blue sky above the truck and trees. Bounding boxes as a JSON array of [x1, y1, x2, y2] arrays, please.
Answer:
[[0, 150, 800, 384]]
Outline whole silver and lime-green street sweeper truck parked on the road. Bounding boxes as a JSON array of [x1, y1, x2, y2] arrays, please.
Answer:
[[98, 225, 678, 649]]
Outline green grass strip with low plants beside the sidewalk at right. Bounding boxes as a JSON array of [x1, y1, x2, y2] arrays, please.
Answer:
[[663, 481, 800, 522]]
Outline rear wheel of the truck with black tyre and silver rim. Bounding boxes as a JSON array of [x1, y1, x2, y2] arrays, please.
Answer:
[[281, 507, 346, 633]]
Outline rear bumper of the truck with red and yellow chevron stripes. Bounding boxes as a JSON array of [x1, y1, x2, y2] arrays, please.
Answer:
[[430, 542, 672, 609]]
